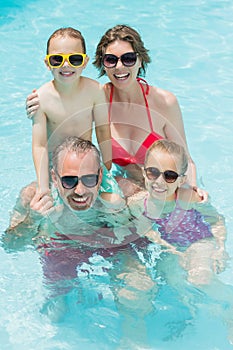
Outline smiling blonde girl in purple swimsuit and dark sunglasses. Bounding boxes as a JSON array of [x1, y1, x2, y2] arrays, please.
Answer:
[[128, 140, 226, 284]]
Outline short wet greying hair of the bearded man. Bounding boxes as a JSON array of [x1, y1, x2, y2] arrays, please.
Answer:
[[52, 136, 100, 172]]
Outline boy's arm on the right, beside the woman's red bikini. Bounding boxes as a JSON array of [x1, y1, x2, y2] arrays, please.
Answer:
[[93, 89, 112, 170]]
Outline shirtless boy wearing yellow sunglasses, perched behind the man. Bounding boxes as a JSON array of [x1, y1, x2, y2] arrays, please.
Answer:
[[29, 28, 112, 205]]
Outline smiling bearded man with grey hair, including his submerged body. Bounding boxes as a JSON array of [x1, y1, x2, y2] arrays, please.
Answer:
[[3, 137, 161, 344]]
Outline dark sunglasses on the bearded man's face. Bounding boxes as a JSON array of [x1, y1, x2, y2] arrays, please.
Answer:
[[59, 170, 99, 190]]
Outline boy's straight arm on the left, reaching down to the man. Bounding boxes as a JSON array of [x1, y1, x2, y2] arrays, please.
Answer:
[[32, 108, 49, 201]]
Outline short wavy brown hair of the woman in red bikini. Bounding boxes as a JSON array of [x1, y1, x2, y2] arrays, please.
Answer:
[[93, 24, 151, 77]]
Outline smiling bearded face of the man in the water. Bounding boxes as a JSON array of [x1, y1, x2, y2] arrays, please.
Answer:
[[52, 150, 102, 211]]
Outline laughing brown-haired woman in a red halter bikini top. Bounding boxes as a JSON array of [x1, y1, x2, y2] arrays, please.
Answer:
[[27, 25, 207, 199]]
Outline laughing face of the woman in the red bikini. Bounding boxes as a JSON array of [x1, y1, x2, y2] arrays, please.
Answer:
[[104, 40, 141, 89]]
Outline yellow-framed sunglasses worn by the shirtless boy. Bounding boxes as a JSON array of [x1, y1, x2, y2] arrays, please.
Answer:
[[45, 53, 87, 68]]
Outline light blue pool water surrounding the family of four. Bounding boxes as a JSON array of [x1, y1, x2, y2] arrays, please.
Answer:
[[0, 0, 233, 350]]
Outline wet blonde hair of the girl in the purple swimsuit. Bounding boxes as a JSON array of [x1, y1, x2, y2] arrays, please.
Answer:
[[145, 140, 188, 175]]
